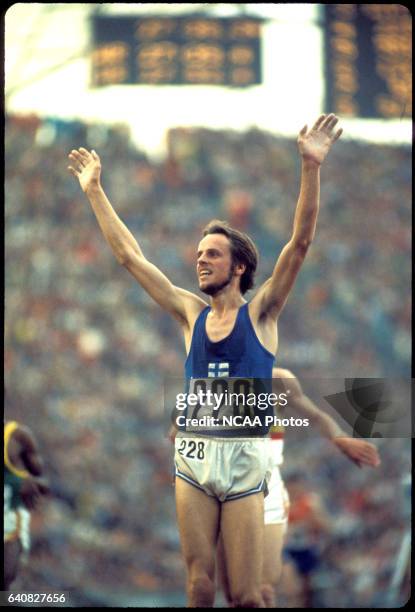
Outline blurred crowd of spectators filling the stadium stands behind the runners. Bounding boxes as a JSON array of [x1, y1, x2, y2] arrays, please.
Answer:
[[5, 116, 411, 607]]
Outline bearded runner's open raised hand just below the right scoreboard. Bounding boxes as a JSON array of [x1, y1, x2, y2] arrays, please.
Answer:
[[297, 113, 343, 164]]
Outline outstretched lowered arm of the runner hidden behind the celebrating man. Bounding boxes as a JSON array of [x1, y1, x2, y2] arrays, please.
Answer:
[[273, 369, 380, 467]]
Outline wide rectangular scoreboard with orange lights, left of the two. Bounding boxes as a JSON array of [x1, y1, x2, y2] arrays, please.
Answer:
[[91, 15, 262, 87]]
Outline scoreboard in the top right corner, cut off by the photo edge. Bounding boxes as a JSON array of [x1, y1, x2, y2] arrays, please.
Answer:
[[324, 4, 412, 118]]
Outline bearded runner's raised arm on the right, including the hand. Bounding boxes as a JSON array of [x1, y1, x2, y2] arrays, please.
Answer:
[[254, 114, 343, 318]]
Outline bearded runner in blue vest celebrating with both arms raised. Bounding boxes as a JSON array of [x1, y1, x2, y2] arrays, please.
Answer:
[[68, 114, 342, 607]]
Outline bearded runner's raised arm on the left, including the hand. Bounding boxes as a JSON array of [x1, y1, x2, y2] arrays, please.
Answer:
[[68, 147, 205, 324]]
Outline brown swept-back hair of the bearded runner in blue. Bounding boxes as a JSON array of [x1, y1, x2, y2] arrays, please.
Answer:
[[203, 219, 259, 295]]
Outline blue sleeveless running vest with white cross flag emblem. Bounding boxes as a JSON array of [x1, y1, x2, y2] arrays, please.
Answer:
[[180, 304, 274, 437]]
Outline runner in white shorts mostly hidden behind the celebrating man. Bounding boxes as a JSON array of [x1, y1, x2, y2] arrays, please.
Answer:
[[218, 368, 380, 608]]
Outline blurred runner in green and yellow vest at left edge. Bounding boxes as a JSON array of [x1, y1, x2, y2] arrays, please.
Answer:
[[4, 421, 49, 591]]
